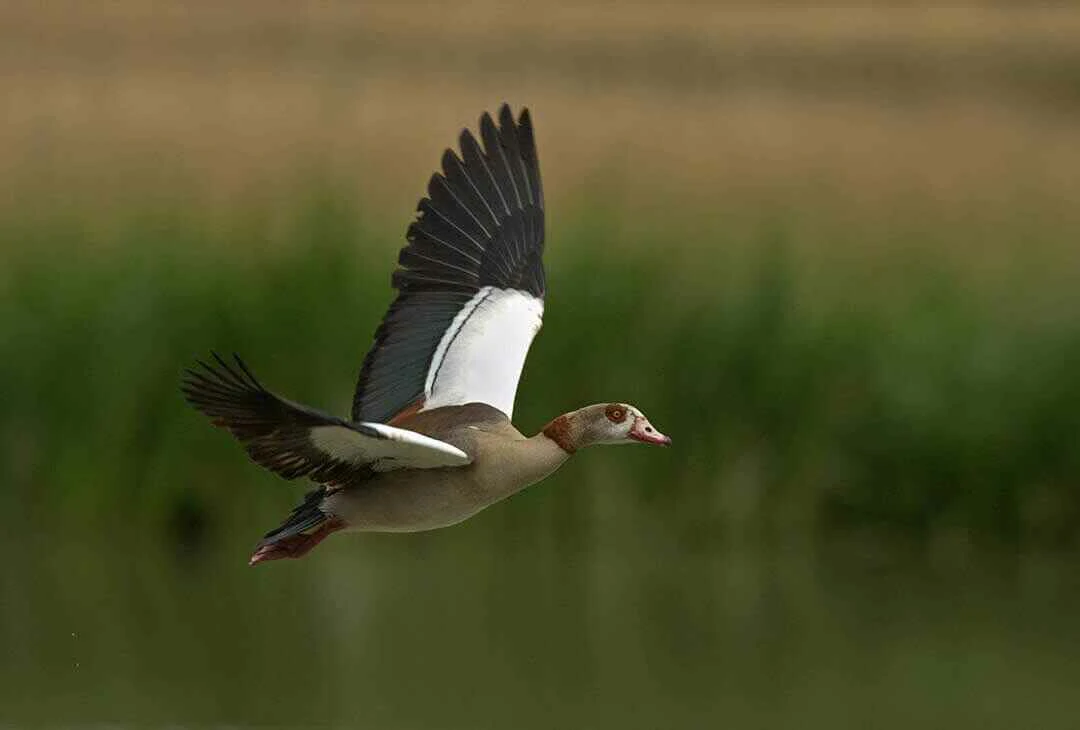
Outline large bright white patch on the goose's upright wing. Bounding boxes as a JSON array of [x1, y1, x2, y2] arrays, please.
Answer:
[[423, 286, 543, 418]]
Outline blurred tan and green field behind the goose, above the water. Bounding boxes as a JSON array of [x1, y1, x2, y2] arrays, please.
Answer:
[[0, 3, 1080, 542]]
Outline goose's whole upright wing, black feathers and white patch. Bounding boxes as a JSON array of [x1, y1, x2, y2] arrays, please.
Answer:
[[352, 105, 545, 422]]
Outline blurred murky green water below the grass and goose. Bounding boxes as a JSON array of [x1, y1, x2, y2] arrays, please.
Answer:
[[0, 514, 1080, 730]]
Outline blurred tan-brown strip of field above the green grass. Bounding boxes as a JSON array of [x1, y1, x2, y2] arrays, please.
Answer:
[[6, 2, 1080, 228]]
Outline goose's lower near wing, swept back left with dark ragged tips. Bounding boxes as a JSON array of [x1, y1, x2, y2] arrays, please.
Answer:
[[181, 353, 471, 487]]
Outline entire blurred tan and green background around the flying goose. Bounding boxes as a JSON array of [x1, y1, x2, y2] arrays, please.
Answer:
[[0, 0, 1080, 729]]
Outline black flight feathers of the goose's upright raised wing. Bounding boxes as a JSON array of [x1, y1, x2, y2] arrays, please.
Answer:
[[352, 105, 546, 423]]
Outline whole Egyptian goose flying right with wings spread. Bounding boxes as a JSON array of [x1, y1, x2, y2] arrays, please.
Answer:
[[181, 105, 671, 565]]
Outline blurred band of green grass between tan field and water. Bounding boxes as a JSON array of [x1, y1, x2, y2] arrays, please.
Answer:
[[0, 186, 1080, 545]]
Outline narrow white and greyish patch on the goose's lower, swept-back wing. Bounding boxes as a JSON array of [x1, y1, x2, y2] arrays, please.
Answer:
[[308, 423, 472, 472]]
